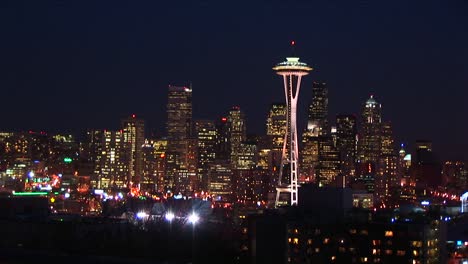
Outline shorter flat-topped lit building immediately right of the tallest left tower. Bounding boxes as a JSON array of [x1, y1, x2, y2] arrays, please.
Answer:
[[195, 120, 217, 190]]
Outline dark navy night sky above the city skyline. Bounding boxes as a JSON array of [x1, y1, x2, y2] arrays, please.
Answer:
[[0, 0, 468, 160]]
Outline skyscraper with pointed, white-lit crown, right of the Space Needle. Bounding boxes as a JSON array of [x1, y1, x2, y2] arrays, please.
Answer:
[[358, 95, 382, 165]]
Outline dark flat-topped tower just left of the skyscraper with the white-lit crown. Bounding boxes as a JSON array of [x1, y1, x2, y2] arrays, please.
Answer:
[[336, 115, 357, 177]]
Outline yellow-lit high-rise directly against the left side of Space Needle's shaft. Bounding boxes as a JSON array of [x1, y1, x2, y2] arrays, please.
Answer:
[[266, 103, 287, 150]]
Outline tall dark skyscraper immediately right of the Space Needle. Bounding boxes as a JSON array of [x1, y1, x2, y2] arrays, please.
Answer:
[[307, 82, 330, 136]]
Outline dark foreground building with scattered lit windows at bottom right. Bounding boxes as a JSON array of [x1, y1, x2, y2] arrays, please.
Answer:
[[246, 185, 446, 264]]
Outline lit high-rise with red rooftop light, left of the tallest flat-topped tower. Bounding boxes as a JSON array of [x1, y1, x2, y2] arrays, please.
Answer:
[[122, 115, 145, 188]]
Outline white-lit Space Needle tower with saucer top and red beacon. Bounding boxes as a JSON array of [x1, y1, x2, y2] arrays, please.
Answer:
[[273, 41, 312, 207]]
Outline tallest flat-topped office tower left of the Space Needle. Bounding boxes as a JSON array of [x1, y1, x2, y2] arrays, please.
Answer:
[[166, 85, 192, 192]]
